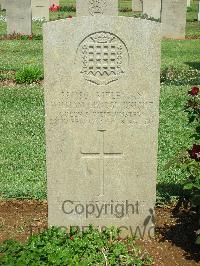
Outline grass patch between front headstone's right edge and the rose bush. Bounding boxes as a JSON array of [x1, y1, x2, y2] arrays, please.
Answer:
[[157, 86, 193, 201]]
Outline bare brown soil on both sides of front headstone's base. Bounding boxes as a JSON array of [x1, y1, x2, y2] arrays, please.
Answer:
[[0, 200, 200, 266]]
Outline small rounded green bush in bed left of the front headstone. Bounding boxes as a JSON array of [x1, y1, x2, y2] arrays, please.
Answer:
[[15, 67, 43, 84]]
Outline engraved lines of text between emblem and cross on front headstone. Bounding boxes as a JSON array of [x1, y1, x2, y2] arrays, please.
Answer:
[[48, 91, 153, 125]]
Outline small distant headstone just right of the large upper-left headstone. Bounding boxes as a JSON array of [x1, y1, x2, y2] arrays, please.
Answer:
[[31, 0, 49, 21]]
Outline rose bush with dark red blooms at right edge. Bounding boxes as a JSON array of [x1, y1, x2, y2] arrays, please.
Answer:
[[167, 86, 200, 243]]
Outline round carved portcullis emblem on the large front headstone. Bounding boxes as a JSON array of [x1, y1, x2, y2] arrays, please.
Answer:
[[78, 32, 128, 85]]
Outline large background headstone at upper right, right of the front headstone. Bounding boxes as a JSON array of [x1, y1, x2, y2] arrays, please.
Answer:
[[161, 0, 187, 39]]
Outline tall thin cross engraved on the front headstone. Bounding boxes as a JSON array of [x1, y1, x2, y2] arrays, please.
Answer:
[[81, 130, 123, 195]]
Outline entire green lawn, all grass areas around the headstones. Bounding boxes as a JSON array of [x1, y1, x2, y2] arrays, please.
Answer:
[[0, 0, 200, 201]]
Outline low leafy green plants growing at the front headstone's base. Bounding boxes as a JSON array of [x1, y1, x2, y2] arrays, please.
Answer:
[[0, 226, 151, 266]]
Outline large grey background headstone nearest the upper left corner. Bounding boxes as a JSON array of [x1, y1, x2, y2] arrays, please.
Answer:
[[6, 0, 32, 35]]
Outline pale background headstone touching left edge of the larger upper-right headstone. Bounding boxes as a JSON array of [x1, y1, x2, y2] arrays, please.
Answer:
[[143, 0, 161, 19]]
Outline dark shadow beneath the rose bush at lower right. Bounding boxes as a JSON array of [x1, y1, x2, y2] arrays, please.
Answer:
[[157, 184, 200, 262]]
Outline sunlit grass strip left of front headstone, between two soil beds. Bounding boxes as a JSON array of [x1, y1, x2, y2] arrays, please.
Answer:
[[0, 87, 46, 198]]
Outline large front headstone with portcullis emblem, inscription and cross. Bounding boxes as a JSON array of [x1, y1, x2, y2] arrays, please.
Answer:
[[44, 16, 160, 237]]
